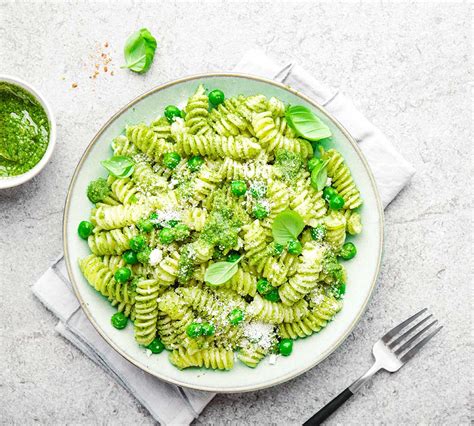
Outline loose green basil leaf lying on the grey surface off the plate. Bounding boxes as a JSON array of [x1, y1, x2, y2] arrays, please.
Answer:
[[122, 28, 156, 73]]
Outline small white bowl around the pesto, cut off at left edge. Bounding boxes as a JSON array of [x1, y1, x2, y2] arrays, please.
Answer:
[[0, 74, 56, 189]]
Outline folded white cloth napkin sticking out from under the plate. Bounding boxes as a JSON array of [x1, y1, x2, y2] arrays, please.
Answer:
[[33, 50, 414, 425]]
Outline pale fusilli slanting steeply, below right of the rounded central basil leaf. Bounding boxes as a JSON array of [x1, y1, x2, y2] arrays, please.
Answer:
[[279, 241, 326, 306]]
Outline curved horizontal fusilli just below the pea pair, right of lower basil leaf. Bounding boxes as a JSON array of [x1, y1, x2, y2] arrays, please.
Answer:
[[248, 294, 308, 324]]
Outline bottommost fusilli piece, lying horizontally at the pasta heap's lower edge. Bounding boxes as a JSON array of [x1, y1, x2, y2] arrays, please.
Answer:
[[169, 347, 234, 370]]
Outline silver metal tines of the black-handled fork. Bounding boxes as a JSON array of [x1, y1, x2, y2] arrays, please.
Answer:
[[382, 308, 443, 363]]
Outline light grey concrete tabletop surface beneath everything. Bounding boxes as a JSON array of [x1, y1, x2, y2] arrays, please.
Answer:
[[0, 1, 472, 425]]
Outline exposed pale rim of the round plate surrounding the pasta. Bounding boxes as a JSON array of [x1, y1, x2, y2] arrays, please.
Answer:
[[63, 74, 383, 392]]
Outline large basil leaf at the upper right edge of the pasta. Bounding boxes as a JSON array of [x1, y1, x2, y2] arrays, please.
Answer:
[[285, 105, 331, 141]]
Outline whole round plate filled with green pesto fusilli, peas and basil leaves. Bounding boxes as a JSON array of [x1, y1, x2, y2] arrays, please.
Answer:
[[63, 74, 383, 392]]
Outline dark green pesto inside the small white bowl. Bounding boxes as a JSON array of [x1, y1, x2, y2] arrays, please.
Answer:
[[0, 83, 49, 177]]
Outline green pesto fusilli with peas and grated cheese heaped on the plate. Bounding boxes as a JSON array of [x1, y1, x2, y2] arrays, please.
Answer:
[[79, 85, 363, 371]]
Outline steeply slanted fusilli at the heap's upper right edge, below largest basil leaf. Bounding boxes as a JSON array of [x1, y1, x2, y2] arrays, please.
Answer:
[[320, 147, 362, 209]]
